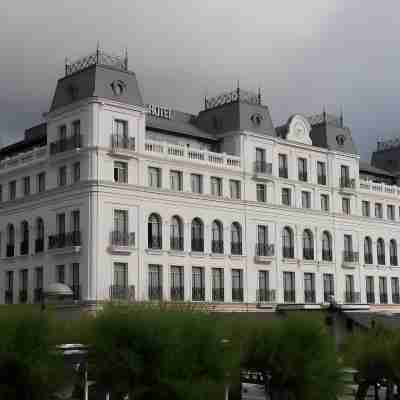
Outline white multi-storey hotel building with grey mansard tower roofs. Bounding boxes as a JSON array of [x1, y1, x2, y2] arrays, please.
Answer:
[[0, 51, 400, 310]]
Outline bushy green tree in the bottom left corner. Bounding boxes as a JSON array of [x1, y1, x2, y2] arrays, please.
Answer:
[[0, 306, 64, 400]]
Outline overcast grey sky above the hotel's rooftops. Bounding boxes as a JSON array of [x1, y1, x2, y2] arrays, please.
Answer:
[[0, 0, 400, 159]]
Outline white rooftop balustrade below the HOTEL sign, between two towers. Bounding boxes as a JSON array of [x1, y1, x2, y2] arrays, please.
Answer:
[[144, 140, 241, 170]]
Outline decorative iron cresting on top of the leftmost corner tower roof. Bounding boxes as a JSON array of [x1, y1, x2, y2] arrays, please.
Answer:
[[65, 48, 128, 76]]
